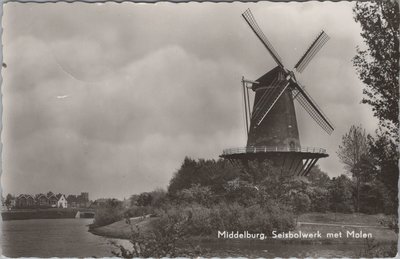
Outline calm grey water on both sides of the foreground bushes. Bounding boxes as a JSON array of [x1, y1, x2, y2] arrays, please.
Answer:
[[0, 219, 376, 258]]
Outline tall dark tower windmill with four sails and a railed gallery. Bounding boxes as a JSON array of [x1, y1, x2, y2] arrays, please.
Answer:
[[221, 9, 334, 176]]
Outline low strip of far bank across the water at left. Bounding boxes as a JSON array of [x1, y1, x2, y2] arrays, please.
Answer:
[[1, 208, 94, 221]]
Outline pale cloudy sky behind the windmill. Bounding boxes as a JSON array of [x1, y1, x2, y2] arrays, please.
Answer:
[[1, 1, 377, 199]]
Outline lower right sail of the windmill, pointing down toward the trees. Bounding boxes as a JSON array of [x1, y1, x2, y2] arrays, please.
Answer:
[[293, 84, 334, 135]]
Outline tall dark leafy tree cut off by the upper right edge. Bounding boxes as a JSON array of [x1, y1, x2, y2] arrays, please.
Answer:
[[353, 0, 400, 139]]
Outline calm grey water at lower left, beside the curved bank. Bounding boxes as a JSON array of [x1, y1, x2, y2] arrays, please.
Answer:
[[1, 219, 127, 257]]
